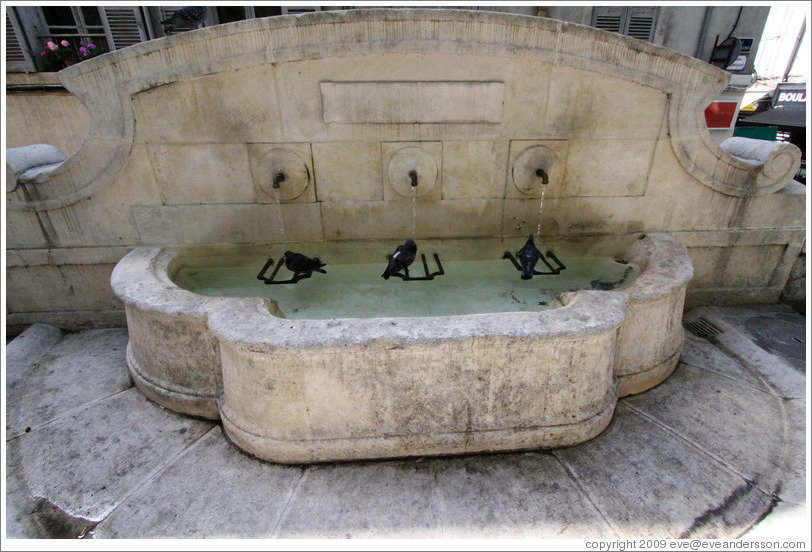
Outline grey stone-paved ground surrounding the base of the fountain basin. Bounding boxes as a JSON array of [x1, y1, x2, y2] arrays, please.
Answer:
[[4, 305, 810, 549]]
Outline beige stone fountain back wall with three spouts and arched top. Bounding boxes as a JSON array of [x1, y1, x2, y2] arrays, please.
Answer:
[[7, 10, 805, 332]]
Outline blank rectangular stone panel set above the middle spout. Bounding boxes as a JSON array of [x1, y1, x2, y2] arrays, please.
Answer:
[[321, 81, 505, 124]]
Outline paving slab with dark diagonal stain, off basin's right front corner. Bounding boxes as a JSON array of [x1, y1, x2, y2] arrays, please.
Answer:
[[553, 403, 771, 538]]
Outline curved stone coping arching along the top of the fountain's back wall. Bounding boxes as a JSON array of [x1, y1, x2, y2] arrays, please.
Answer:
[[7, 9, 772, 211]]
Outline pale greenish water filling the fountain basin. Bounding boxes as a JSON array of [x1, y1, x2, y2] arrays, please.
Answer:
[[174, 255, 638, 319]]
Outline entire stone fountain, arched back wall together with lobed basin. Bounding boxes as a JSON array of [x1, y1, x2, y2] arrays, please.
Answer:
[[7, 10, 804, 463]]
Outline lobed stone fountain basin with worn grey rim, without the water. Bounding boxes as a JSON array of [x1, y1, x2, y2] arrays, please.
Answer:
[[112, 234, 693, 463]]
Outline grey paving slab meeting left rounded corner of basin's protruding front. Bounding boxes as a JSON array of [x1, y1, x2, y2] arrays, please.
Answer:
[[93, 426, 302, 539]]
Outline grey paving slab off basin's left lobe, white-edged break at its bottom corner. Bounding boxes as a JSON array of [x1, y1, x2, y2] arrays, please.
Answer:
[[9, 387, 214, 522]]
